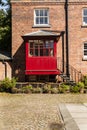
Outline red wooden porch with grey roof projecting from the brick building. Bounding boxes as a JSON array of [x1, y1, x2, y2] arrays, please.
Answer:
[[23, 31, 63, 80]]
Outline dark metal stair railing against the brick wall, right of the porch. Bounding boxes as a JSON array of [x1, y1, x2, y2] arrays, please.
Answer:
[[57, 57, 83, 82]]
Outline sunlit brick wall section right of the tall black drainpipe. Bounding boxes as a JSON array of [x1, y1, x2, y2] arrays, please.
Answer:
[[69, 3, 87, 74]]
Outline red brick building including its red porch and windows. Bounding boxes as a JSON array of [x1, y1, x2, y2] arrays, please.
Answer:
[[11, 0, 87, 81]]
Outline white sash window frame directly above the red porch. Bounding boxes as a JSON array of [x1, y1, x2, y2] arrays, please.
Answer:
[[34, 8, 49, 26]]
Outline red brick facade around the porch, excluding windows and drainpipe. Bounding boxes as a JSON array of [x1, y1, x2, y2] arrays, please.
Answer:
[[11, 0, 87, 81]]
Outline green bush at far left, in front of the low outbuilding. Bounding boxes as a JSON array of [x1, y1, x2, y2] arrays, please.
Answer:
[[0, 78, 16, 92]]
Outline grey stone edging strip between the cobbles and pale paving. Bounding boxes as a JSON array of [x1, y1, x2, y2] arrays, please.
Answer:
[[59, 103, 79, 130]]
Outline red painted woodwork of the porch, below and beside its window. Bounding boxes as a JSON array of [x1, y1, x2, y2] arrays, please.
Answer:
[[25, 42, 59, 75]]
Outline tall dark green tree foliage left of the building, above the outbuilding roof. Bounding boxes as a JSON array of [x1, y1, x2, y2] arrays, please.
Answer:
[[0, 0, 11, 52]]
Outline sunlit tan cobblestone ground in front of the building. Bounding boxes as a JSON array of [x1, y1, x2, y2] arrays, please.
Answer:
[[0, 94, 87, 130]]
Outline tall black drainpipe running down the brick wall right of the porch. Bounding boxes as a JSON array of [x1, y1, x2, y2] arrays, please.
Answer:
[[65, 0, 70, 77]]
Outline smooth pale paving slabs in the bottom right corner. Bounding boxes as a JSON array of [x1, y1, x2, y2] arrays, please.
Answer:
[[66, 104, 87, 130]]
